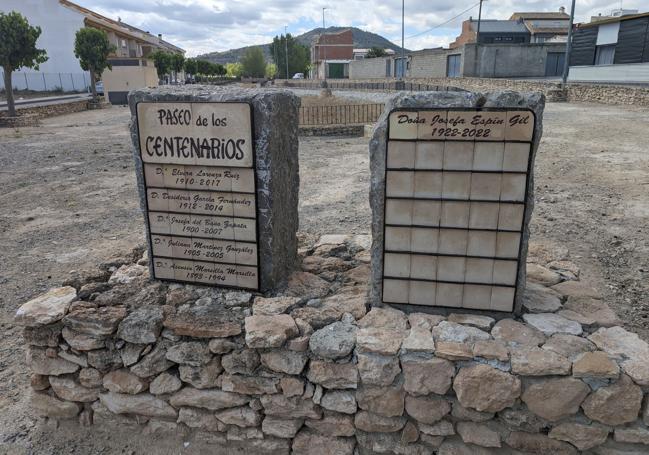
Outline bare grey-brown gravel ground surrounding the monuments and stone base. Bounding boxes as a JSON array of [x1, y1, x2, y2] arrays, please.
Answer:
[[0, 98, 649, 454]]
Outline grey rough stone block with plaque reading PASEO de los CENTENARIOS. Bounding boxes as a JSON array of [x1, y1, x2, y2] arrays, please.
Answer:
[[129, 86, 299, 291]]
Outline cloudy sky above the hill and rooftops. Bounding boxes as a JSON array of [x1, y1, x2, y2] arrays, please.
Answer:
[[83, 0, 647, 56]]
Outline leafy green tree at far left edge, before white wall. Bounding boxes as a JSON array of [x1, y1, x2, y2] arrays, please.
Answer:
[[0, 11, 47, 117]]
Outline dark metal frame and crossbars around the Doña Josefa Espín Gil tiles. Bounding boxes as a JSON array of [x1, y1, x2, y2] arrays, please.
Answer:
[[380, 107, 537, 313]]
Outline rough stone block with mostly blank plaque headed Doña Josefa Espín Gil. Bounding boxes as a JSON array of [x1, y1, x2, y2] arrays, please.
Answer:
[[370, 92, 544, 312]]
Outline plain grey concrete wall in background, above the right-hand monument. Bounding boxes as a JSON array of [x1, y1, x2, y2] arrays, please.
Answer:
[[462, 43, 566, 77]]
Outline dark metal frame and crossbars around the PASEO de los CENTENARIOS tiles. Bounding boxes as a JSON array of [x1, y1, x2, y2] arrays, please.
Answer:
[[135, 101, 261, 291]]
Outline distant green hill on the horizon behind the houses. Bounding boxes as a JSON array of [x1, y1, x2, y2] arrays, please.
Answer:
[[197, 27, 408, 65]]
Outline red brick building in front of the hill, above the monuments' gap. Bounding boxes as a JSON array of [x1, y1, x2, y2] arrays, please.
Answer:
[[311, 29, 354, 79]]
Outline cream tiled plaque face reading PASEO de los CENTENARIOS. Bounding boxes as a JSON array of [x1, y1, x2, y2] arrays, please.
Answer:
[[137, 102, 260, 290]]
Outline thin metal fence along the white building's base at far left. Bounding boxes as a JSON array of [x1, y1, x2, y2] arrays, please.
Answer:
[[0, 71, 90, 92]]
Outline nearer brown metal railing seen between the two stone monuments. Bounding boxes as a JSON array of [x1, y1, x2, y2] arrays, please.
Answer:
[[300, 103, 384, 126]]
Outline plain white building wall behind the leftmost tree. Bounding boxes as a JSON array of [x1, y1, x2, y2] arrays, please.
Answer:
[[0, 0, 90, 91]]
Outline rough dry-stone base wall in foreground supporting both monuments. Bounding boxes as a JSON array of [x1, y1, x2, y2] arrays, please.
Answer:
[[16, 235, 649, 455]]
